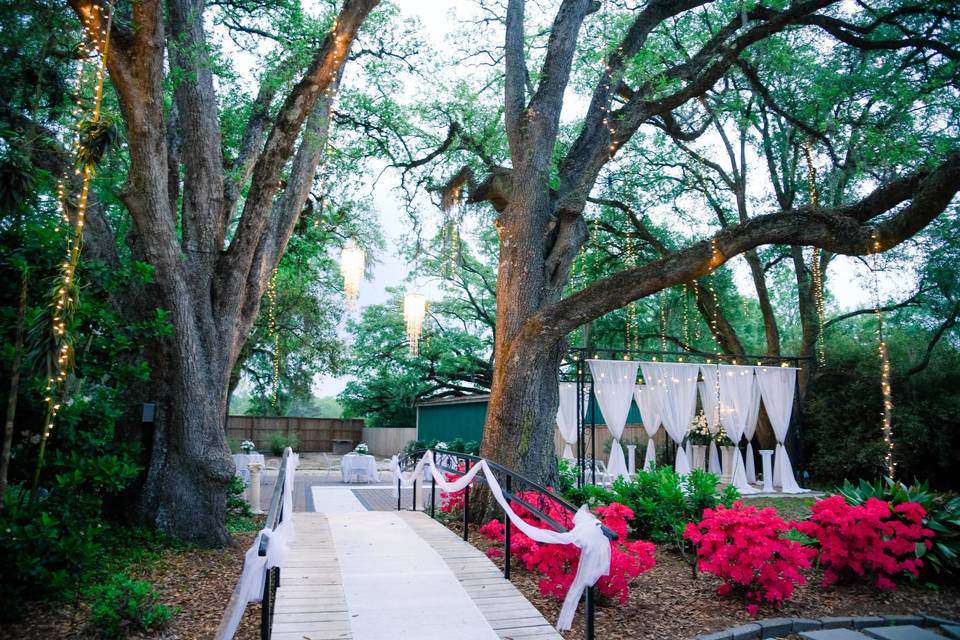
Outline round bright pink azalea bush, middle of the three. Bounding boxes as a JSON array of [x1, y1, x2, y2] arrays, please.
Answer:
[[683, 501, 816, 615]]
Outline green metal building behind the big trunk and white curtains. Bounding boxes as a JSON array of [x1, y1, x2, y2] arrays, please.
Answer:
[[417, 394, 641, 442]]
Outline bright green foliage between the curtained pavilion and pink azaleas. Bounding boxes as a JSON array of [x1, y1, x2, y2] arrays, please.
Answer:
[[561, 467, 739, 545]]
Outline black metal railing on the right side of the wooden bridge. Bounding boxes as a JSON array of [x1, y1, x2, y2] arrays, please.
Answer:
[[397, 449, 617, 640]]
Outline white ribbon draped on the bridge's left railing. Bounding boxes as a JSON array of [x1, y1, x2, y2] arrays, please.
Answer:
[[217, 449, 300, 639]]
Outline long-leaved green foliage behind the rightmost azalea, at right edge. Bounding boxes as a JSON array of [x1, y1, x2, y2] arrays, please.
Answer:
[[838, 478, 960, 579]]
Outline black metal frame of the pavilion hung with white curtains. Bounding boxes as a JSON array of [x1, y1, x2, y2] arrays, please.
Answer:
[[569, 347, 813, 487]]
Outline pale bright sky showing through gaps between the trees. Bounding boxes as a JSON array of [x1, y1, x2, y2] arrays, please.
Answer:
[[251, 0, 916, 396]]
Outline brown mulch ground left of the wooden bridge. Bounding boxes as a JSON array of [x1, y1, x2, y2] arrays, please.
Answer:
[[0, 532, 260, 640]]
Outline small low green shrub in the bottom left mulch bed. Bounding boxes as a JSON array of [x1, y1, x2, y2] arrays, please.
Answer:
[[90, 574, 175, 638]]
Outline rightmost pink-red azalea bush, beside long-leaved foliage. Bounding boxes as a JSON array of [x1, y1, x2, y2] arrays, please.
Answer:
[[796, 496, 934, 589]]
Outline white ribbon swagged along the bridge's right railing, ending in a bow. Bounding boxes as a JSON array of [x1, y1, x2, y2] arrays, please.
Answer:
[[390, 451, 610, 631]]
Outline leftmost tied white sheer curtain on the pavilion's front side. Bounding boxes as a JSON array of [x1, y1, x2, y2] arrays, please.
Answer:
[[588, 360, 640, 481]]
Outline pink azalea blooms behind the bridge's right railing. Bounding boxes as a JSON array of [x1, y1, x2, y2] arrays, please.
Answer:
[[480, 492, 655, 604]]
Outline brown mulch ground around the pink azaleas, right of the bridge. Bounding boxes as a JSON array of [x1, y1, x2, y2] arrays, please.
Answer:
[[448, 523, 960, 640]]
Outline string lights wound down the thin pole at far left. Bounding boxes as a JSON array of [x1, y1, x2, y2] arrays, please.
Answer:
[[34, 4, 113, 486]]
